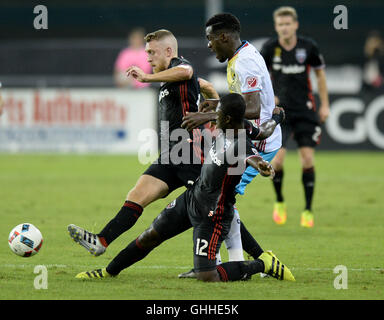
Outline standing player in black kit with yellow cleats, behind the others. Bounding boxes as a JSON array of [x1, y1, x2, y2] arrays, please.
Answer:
[[261, 7, 329, 227]]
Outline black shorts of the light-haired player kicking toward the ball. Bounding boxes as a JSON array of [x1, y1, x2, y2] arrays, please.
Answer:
[[143, 158, 202, 193]]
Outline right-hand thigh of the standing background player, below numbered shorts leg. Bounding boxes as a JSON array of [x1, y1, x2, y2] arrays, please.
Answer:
[[294, 120, 321, 169]]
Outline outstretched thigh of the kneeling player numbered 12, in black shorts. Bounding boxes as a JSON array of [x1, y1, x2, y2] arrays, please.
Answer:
[[150, 191, 192, 241]]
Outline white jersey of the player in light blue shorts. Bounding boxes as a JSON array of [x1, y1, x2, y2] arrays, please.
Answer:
[[227, 41, 281, 152]]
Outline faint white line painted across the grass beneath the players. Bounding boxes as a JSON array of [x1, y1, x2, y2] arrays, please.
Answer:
[[0, 264, 384, 272]]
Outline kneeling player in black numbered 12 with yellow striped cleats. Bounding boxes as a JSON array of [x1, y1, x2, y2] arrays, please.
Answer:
[[76, 93, 295, 282]]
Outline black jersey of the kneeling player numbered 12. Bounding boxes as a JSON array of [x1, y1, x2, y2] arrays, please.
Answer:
[[191, 133, 259, 220]]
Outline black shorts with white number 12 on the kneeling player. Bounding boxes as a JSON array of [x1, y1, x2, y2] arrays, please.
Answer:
[[152, 189, 233, 272]]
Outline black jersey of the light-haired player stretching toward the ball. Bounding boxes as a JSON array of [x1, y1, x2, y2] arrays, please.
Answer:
[[159, 58, 200, 159]]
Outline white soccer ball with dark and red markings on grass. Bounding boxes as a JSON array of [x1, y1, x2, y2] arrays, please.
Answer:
[[8, 223, 43, 257]]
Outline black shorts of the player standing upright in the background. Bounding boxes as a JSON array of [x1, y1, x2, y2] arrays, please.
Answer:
[[280, 110, 321, 148]]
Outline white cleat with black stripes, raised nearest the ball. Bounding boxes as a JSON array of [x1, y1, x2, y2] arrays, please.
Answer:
[[68, 224, 106, 257]]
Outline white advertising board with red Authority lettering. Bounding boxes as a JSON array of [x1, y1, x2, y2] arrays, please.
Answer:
[[0, 89, 157, 154]]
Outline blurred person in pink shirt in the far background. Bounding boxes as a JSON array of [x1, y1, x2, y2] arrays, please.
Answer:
[[114, 28, 151, 89]]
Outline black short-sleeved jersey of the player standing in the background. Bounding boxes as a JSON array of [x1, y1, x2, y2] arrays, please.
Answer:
[[260, 36, 324, 112]]
